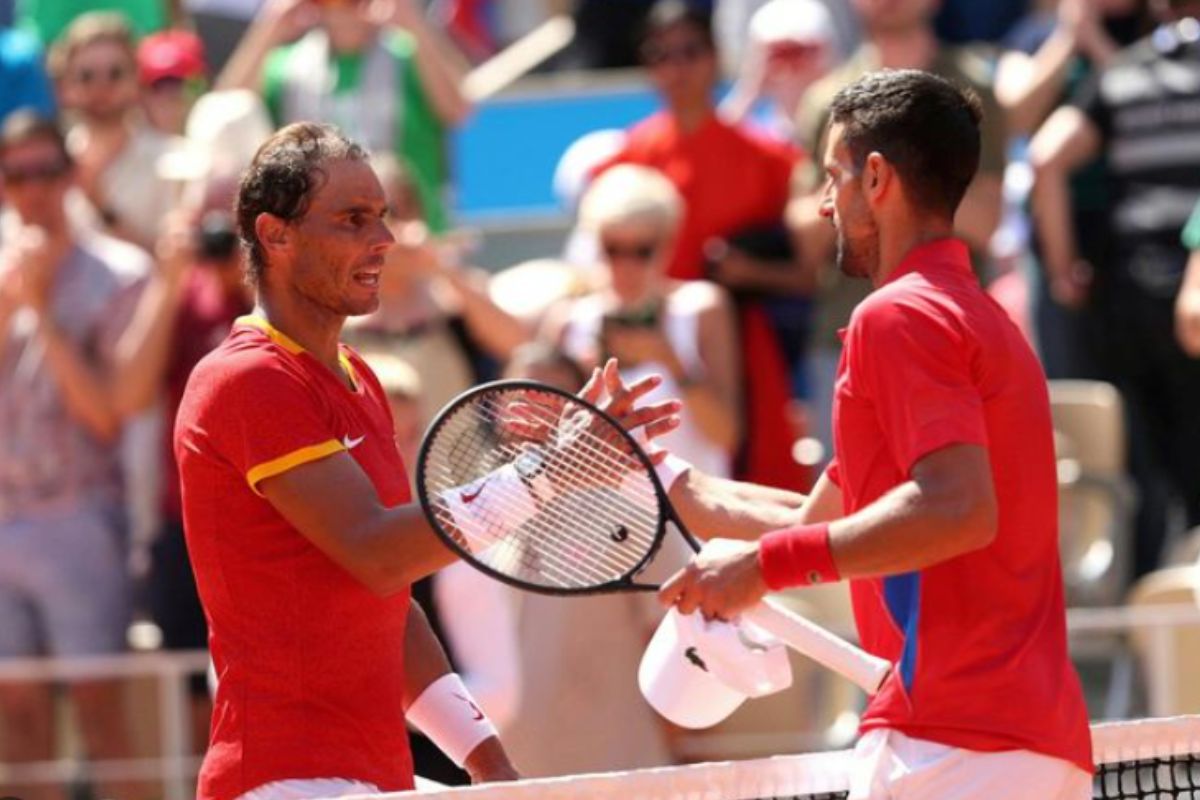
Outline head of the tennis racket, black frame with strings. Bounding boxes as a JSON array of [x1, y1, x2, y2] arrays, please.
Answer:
[[415, 380, 686, 595]]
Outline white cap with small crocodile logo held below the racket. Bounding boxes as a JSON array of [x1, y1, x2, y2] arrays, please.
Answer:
[[637, 608, 792, 728]]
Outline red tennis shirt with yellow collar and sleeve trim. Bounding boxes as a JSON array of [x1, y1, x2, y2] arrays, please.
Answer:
[[175, 317, 413, 800]]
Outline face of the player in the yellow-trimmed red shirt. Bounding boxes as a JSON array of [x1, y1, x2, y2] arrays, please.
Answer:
[[279, 154, 395, 317]]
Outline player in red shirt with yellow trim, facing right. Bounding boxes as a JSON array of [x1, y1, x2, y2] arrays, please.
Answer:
[[175, 122, 674, 800]]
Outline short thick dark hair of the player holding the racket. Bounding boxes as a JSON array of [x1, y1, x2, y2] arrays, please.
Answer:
[[829, 70, 983, 217]]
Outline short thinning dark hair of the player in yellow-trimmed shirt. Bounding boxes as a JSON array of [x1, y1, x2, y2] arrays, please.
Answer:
[[234, 122, 367, 285]]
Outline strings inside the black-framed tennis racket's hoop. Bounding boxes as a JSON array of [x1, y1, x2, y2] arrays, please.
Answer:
[[425, 392, 659, 588]]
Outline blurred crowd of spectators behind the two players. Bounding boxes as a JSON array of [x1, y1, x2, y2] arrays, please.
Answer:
[[0, 0, 1200, 800]]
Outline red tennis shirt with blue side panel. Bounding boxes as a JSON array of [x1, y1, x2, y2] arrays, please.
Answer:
[[829, 240, 1092, 771]]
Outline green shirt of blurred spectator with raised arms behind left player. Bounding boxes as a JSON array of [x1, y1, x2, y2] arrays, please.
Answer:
[[263, 31, 449, 233]]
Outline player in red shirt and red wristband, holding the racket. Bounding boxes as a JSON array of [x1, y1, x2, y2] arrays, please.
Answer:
[[660, 71, 1092, 800]]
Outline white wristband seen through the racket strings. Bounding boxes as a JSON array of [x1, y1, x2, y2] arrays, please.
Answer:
[[442, 463, 538, 553]]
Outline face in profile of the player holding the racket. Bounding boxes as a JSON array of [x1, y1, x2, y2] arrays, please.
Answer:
[[821, 125, 880, 278]]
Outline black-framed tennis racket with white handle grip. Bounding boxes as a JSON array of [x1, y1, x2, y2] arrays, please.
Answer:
[[416, 380, 890, 693]]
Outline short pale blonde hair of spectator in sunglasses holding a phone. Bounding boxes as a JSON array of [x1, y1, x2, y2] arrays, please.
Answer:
[[580, 164, 683, 235]]
